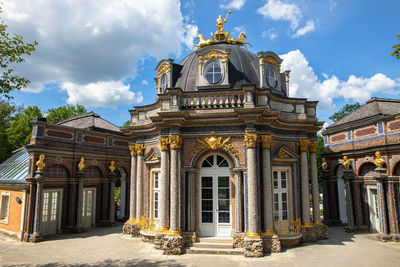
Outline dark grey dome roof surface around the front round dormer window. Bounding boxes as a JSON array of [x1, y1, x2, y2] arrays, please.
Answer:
[[174, 43, 260, 91]]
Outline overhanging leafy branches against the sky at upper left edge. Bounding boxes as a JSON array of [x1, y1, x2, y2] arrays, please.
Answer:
[[0, 7, 38, 99]]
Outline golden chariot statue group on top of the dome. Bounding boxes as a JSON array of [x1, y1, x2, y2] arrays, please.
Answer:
[[193, 10, 252, 48]]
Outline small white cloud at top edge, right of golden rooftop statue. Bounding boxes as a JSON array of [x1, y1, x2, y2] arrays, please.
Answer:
[[257, 0, 302, 30]]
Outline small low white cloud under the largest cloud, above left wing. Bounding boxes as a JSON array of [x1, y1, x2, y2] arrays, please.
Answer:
[[61, 81, 143, 107]]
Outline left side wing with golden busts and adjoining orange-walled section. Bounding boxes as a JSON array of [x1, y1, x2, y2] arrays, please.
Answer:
[[0, 113, 130, 242]]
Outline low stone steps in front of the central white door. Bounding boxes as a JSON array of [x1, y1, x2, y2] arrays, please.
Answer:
[[186, 237, 243, 255]]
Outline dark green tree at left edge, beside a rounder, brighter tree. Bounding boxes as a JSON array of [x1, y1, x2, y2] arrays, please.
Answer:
[[0, 100, 15, 163]]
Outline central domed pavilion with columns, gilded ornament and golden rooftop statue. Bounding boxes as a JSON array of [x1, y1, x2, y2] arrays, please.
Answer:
[[123, 12, 327, 256]]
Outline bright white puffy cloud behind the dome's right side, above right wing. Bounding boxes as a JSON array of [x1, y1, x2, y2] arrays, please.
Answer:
[[281, 50, 400, 109]]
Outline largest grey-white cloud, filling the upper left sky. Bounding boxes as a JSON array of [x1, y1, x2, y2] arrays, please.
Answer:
[[2, 0, 197, 106]]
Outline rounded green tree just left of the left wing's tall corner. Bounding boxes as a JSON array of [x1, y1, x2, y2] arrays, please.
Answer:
[[7, 106, 42, 150]]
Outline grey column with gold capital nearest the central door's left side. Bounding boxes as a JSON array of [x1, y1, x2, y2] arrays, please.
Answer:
[[169, 135, 182, 236]]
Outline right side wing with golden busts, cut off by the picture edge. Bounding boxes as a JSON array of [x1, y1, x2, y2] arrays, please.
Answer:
[[323, 98, 400, 240]]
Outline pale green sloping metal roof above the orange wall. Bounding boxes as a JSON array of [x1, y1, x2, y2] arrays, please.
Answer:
[[0, 147, 29, 183]]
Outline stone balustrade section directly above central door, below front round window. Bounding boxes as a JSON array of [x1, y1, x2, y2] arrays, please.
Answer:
[[181, 94, 244, 109]]
